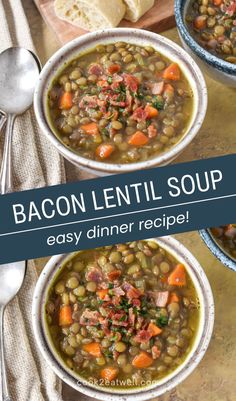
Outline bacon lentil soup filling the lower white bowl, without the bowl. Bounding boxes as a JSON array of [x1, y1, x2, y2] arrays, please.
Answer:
[[46, 241, 200, 388]]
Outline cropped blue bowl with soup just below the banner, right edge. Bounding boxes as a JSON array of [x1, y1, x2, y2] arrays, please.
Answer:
[[200, 224, 236, 271]]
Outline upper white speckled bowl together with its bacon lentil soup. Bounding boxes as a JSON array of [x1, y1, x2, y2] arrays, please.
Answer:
[[34, 28, 207, 175]]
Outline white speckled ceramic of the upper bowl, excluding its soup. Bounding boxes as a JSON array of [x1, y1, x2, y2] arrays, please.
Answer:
[[34, 28, 207, 175]]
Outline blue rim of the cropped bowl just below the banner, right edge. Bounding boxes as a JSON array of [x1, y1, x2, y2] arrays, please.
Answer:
[[199, 229, 236, 272]]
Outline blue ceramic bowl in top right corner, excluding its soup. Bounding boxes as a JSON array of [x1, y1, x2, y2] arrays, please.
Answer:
[[175, 0, 236, 88]]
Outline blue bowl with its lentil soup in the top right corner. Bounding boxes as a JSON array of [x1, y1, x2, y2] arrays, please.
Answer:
[[175, 0, 236, 87]]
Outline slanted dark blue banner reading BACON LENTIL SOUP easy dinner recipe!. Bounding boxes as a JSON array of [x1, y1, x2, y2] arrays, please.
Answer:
[[0, 155, 236, 263]]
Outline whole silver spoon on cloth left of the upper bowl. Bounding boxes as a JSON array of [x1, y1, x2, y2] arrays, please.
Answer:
[[0, 47, 40, 194]]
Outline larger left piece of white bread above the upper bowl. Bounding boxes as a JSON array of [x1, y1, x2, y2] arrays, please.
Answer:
[[54, 0, 126, 31]]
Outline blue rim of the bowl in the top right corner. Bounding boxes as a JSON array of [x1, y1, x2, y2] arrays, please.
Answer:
[[174, 0, 236, 75]]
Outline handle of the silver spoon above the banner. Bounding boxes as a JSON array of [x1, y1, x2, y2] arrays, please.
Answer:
[[0, 114, 15, 195]]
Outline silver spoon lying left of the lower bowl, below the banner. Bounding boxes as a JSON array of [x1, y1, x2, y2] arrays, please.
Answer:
[[0, 261, 26, 401]]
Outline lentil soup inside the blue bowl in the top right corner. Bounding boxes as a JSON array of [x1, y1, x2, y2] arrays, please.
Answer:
[[186, 0, 236, 64]]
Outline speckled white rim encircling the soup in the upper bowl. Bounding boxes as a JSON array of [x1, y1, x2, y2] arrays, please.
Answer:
[[34, 28, 208, 174]]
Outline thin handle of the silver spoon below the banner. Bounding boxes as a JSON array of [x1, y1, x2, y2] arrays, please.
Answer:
[[0, 306, 11, 401]]
